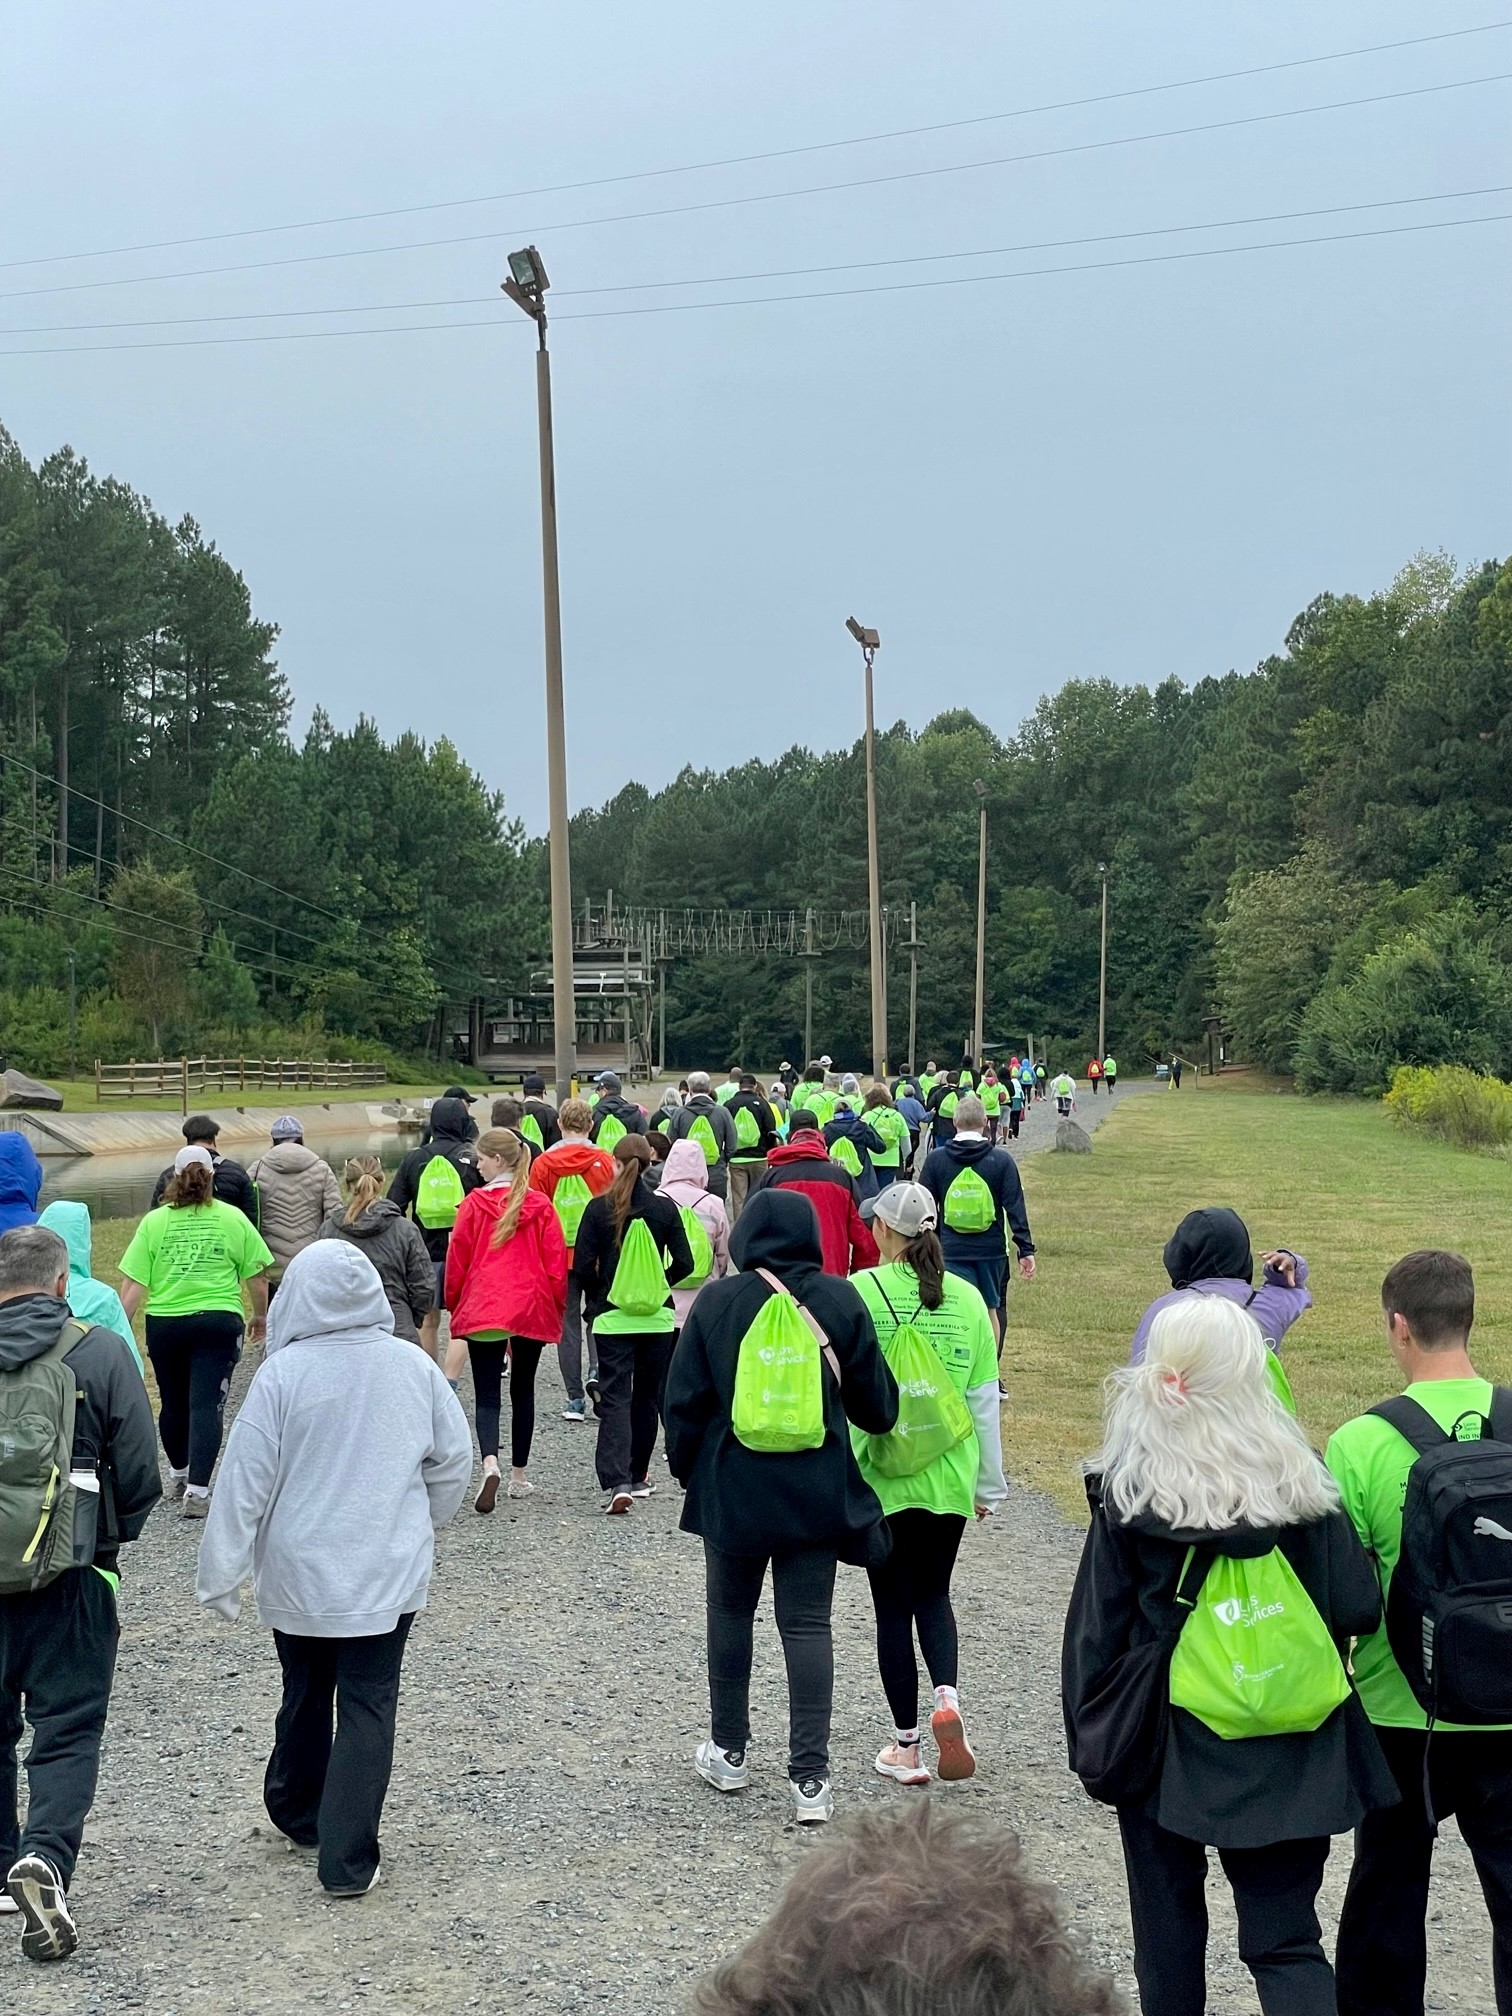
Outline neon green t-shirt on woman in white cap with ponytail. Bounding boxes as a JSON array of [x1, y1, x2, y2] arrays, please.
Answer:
[[851, 1260, 998, 1518]]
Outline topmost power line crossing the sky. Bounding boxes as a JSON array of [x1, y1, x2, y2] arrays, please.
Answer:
[[0, 20, 1512, 272]]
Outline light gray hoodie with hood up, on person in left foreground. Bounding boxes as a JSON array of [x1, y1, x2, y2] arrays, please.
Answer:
[[196, 1240, 472, 1637]]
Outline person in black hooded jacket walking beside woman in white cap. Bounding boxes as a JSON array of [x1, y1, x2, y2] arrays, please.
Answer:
[[667, 1189, 897, 1824]]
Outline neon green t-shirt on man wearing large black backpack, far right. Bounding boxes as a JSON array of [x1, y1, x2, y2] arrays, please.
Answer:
[[1330, 1370, 1492, 1732]]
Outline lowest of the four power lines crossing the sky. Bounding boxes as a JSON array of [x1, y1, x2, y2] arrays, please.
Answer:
[[0, 210, 1512, 358]]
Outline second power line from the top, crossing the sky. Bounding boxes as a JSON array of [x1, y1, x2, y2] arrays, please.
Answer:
[[0, 71, 1512, 300]]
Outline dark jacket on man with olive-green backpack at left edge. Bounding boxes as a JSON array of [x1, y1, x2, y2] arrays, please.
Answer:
[[0, 1290, 163, 1572]]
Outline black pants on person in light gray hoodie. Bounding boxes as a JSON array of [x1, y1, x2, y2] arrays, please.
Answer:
[[262, 1615, 415, 1889]]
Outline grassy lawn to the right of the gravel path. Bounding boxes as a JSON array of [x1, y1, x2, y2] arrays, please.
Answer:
[[1002, 1079, 1512, 1516]]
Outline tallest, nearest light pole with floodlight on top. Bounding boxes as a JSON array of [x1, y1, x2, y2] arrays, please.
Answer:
[[502, 246, 577, 1105]]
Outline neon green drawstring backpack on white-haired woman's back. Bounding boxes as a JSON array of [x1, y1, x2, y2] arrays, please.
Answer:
[[1171, 1546, 1349, 1742]]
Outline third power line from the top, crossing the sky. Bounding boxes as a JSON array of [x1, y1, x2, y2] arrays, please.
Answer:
[[0, 181, 1512, 338]]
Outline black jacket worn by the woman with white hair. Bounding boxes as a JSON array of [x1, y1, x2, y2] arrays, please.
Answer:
[[1060, 1478, 1399, 1849]]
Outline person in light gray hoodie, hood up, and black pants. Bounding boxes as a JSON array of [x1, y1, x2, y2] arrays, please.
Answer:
[[196, 1240, 472, 1897]]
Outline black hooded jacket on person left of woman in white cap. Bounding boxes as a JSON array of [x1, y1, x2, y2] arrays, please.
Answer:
[[665, 1189, 897, 1562]]
